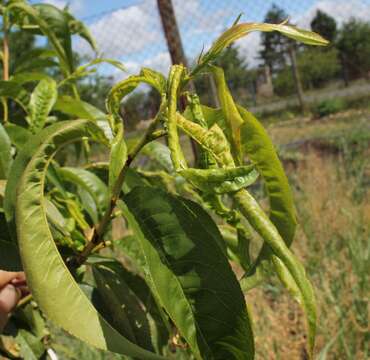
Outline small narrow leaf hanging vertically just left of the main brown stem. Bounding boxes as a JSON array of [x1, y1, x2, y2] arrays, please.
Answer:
[[109, 124, 127, 196]]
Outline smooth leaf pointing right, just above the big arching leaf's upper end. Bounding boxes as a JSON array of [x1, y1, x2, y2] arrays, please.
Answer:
[[53, 95, 106, 120]]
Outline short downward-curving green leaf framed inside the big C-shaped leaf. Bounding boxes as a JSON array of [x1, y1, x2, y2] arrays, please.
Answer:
[[58, 167, 109, 212]]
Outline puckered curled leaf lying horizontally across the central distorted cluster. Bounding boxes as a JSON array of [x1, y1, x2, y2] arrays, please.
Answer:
[[179, 165, 258, 194]]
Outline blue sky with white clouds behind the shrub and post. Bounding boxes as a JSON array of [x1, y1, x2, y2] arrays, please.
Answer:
[[32, 0, 370, 77]]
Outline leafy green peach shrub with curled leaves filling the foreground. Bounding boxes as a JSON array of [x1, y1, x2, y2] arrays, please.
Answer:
[[0, 1, 326, 359]]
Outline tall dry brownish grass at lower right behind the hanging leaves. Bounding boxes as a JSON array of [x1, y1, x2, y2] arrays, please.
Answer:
[[247, 151, 370, 360]]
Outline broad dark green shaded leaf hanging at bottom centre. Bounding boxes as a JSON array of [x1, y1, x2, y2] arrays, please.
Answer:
[[125, 187, 254, 359]]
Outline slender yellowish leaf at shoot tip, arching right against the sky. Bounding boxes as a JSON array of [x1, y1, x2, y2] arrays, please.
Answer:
[[191, 23, 328, 75]]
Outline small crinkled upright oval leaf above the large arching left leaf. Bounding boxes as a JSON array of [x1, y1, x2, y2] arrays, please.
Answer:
[[28, 78, 58, 133]]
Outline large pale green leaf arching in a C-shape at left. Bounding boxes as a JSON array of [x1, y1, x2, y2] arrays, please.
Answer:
[[16, 120, 162, 359]]
